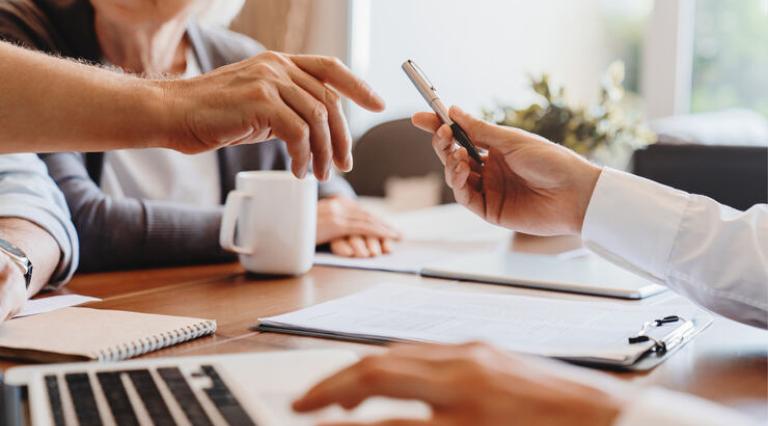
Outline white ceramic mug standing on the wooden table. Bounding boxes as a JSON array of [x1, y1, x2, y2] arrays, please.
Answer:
[[219, 171, 317, 275]]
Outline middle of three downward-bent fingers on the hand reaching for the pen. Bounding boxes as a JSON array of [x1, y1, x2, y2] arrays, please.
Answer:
[[278, 84, 332, 180]]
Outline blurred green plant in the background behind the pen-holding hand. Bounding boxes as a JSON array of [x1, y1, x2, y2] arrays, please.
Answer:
[[483, 62, 656, 169]]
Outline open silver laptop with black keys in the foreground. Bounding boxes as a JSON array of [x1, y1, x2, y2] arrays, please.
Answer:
[[2, 350, 429, 426]]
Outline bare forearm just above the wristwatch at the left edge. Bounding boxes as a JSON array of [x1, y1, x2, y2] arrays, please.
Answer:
[[0, 218, 61, 297]]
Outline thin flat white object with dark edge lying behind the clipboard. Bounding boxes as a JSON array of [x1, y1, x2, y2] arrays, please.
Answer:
[[421, 251, 665, 299]]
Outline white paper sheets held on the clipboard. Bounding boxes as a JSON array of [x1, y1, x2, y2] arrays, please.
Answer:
[[259, 284, 711, 362]]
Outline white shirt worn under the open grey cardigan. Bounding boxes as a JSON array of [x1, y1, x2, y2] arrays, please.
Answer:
[[101, 49, 221, 206]]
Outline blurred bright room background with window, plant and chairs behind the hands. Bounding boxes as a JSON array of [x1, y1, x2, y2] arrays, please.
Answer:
[[219, 0, 768, 209]]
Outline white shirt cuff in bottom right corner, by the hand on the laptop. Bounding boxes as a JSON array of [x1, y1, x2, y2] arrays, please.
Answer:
[[614, 388, 757, 426]]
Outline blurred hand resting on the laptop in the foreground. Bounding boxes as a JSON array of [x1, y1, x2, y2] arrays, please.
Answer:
[[293, 343, 631, 426]]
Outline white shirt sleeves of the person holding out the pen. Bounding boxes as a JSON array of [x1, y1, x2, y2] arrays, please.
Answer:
[[582, 169, 768, 426]]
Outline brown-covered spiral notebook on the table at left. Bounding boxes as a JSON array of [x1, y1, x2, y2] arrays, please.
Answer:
[[0, 308, 216, 362]]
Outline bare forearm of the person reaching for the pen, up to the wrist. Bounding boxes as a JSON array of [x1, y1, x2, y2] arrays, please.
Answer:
[[0, 42, 170, 153]]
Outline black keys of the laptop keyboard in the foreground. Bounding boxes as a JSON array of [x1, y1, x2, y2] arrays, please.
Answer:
[[44, 365, 256, 426]]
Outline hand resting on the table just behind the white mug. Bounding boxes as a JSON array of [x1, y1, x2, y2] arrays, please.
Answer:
[[317, 197, 400, 257]]
